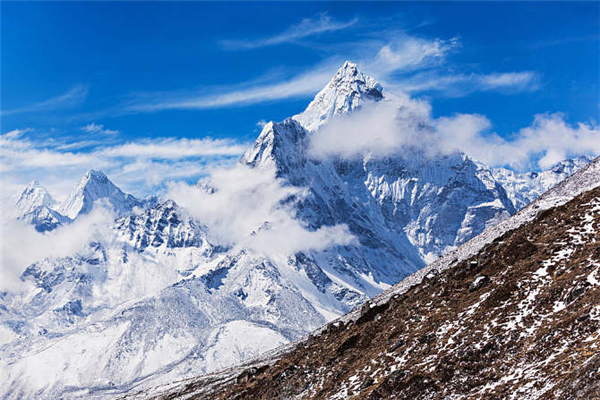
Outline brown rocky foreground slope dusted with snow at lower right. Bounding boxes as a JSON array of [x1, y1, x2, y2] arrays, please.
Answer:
[[137, 159, 600, 399]]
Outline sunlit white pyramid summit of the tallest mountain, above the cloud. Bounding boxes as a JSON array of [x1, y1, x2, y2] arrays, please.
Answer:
[[293, 61, 384, 131]]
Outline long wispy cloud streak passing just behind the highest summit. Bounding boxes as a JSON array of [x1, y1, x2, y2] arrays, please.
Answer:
[[127, 33, 540, 113]]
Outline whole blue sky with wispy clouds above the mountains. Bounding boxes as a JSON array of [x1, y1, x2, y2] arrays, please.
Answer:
[[0, 2, 600, 197]]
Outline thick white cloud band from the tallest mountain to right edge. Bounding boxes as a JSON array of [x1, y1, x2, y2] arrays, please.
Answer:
[[310, 99, 600, 170]]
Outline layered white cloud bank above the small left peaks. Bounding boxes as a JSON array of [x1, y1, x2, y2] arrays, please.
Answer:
[[0, 130, 248, 197]]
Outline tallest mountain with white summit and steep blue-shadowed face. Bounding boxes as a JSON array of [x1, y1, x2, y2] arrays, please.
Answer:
[[242, 62, 516, 266]]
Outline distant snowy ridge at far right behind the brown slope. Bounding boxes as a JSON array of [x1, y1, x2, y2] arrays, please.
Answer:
[[492, 156, 592, 209]]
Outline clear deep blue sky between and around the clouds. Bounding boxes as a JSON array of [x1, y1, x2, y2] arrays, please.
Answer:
[[0, 2, 600, 148]]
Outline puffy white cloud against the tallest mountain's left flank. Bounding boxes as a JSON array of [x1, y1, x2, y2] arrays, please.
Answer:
[[166, 164, 354, 254]]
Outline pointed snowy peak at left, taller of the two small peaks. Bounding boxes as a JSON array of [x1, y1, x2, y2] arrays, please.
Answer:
[[60, 170, 143, 219]]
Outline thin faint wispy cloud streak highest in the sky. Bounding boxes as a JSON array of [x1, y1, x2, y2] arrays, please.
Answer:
[[220, 13, 358, 50]]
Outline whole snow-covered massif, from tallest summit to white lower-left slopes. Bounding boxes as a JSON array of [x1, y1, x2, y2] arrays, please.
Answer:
[[0, 63, 592, 398]]
